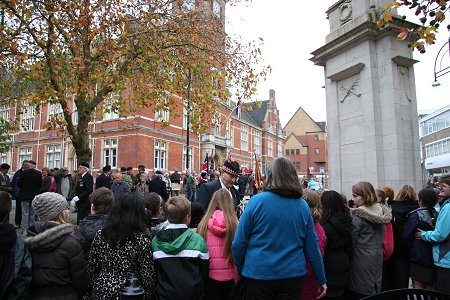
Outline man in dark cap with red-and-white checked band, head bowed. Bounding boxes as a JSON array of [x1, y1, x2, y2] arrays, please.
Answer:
[[197, 159, 239, 210]]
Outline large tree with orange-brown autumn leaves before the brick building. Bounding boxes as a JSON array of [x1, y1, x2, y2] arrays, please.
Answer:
[[0, 0, 267, 160]]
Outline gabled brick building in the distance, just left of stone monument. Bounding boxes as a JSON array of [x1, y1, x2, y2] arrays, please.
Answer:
[[284, 107, 328, 182]]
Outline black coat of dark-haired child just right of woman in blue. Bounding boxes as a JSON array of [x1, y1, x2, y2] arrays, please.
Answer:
[[321, 215, 353, 292]]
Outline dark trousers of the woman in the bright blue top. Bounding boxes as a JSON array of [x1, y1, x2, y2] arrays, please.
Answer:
[[245, 277, 303, 300]]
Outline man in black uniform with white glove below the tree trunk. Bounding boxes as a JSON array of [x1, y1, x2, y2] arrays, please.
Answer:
[[72, 162, 94, 224]]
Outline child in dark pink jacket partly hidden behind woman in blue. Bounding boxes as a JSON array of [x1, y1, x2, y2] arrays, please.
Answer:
[[300, 190, 327, 300]]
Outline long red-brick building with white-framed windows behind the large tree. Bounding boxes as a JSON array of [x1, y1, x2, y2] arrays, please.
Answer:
[[0, 90, 284, 174]]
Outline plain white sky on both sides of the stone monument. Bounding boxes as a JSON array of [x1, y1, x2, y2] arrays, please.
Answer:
[[226, 0, 450, 127]]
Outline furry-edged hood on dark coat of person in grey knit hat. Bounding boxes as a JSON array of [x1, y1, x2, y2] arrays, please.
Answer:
[[24, 221, 73, 252]]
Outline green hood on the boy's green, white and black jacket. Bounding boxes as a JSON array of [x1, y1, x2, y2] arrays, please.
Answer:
[[154, 228, 194, 255]]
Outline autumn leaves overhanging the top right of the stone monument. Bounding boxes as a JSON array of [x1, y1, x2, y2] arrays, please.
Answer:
[[377, 0, 450, 53]]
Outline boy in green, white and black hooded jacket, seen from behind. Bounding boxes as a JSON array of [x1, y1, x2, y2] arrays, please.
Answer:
[[152, 196, 209, 299]]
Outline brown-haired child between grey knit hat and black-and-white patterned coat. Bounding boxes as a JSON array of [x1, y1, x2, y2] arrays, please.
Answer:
[[75, 187, 114, 261]]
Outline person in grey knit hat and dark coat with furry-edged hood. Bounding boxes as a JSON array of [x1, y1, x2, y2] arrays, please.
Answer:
[[25, 192, 87, 300]]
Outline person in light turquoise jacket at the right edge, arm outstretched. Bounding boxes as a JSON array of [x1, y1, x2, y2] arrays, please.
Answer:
[[416, 173, 450, 294]]
